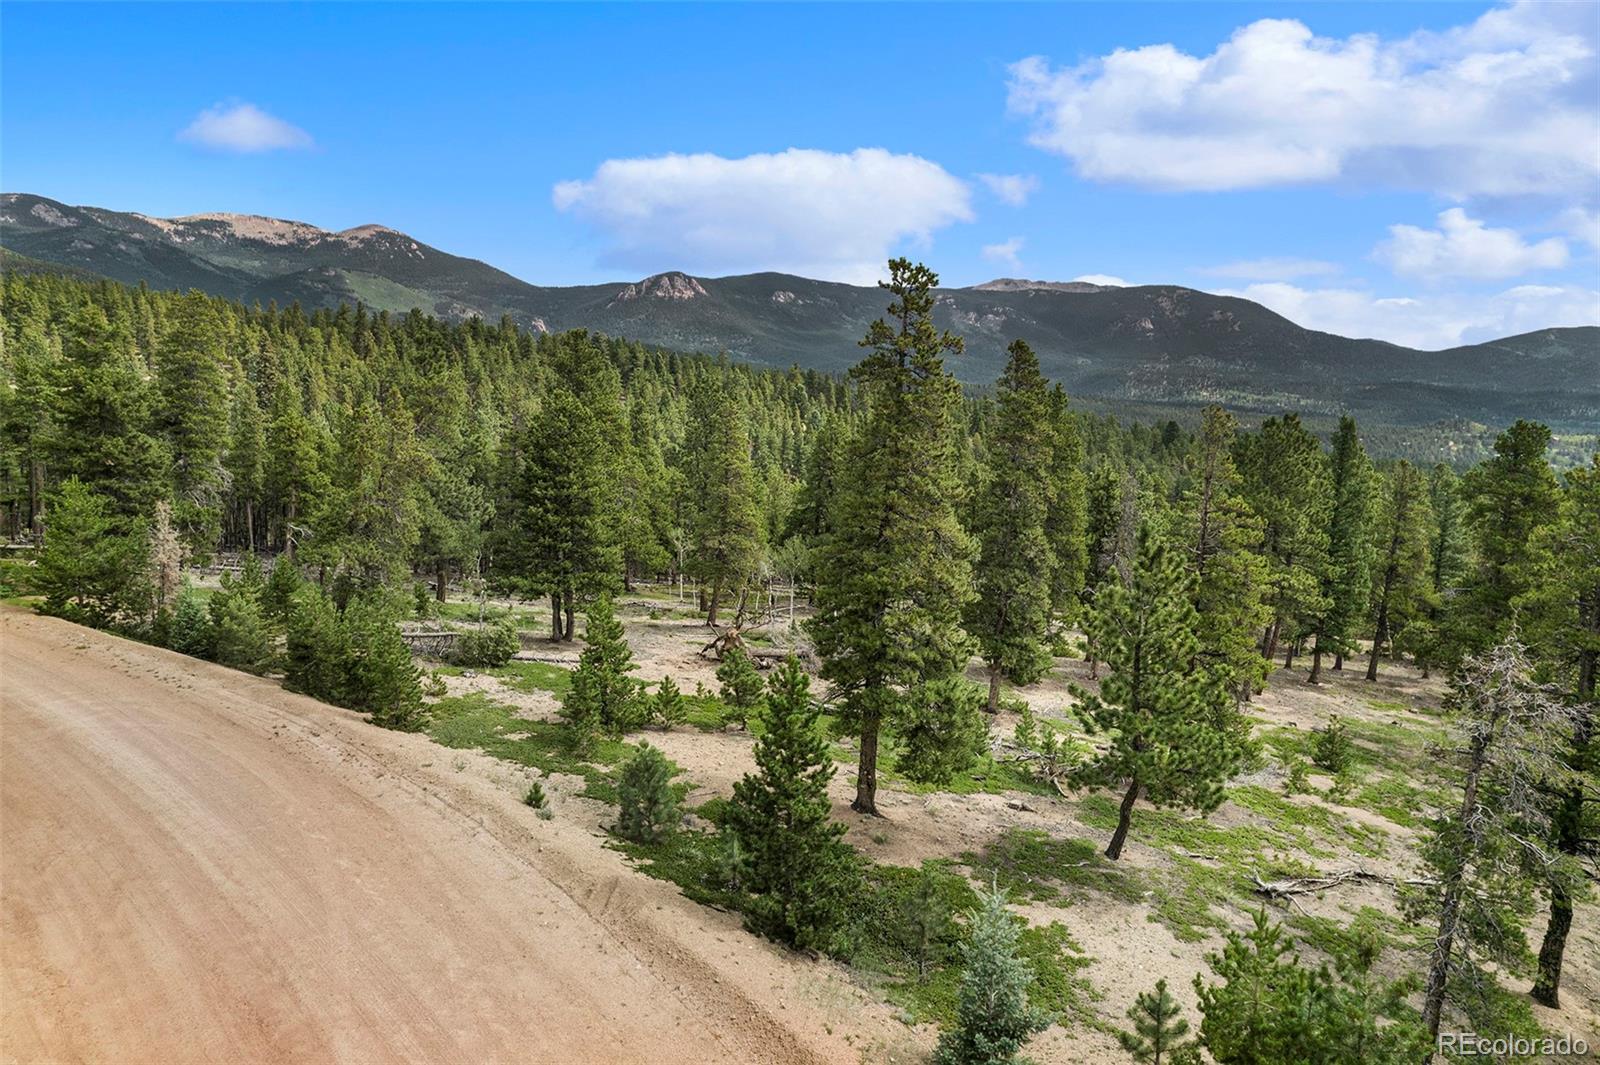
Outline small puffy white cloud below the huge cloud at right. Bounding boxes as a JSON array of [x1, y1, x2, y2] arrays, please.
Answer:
[[1373, 208, 1566, 278]]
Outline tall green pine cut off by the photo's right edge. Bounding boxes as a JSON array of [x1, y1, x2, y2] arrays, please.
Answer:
[[1514, 454, 1600, 1009]]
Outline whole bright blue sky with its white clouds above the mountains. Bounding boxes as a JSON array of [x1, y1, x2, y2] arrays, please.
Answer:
[[0, 2, 1600, 347]]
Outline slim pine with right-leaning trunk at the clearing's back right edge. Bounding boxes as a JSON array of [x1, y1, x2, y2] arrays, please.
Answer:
[[1366, 459, 1432, 681]]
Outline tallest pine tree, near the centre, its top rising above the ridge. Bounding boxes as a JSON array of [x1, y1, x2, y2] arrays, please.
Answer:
[[810, 259, 971, 814]]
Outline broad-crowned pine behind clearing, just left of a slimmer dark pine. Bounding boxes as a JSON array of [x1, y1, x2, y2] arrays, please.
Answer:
[[1235, 414, 1333, 659]]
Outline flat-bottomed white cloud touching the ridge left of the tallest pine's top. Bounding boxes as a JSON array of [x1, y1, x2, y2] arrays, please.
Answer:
[[552, 149, 973, 283]]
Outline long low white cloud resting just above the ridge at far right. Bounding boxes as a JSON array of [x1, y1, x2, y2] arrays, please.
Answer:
[[1221, 281, 1600, 350]]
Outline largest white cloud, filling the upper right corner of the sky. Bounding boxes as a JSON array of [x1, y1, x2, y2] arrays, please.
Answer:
[[1010, 0, 1600, 198]]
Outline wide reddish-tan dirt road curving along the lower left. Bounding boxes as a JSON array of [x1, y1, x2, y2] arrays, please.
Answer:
[[0, 609, 872, 1063]]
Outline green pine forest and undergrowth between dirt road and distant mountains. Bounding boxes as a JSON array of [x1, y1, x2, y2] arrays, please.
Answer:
[[0, 261, 1600, 1065]]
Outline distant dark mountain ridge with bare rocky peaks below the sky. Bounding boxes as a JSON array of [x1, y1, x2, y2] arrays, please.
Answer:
[[0, 193, 1600, 432]]
